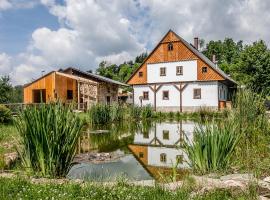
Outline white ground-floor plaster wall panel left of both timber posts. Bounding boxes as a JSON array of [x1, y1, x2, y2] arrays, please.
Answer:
[[133, 85, 154, 106]]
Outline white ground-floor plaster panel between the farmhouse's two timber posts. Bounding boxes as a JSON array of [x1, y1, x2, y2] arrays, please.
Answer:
[[156, 84, 180, 107]]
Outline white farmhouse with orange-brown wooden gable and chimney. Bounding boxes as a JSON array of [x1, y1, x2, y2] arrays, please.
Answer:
[[127, 30, 237, 112]]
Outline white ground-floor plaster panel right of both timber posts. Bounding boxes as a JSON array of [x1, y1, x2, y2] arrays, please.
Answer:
[[182, 81, 218, 107]]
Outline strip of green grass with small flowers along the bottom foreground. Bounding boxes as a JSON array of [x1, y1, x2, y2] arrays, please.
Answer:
[[0, 178, 257, 200]]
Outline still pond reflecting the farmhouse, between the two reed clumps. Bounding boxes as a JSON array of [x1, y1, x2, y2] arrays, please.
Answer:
[[67, 121, 195, 181]]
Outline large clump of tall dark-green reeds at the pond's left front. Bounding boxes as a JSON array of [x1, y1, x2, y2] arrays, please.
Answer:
[[15, 103, 82, 177]]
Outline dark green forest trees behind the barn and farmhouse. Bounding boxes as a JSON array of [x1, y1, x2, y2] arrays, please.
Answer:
[[0, 38, 270, 103]]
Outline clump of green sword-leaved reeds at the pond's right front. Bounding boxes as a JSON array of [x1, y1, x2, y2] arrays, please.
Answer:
[[184, 119, 240, 174]]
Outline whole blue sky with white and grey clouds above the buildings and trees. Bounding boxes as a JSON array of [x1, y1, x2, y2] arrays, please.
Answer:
[[0, 0, 270, 85]]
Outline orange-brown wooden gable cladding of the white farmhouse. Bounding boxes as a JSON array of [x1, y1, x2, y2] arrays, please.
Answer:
[[128, 31, 224, 85]]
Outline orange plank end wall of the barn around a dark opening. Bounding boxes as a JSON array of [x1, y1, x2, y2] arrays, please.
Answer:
[[23, 72, 55, 103]]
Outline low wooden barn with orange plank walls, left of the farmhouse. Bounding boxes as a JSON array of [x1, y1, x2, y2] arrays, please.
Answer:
[[24, 68, 127, 109]]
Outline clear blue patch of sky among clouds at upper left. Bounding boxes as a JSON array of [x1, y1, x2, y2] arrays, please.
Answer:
[[0, 4, 59, 55]]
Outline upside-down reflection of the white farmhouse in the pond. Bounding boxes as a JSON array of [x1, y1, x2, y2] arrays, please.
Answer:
[[128, 121, 194, 180]]
